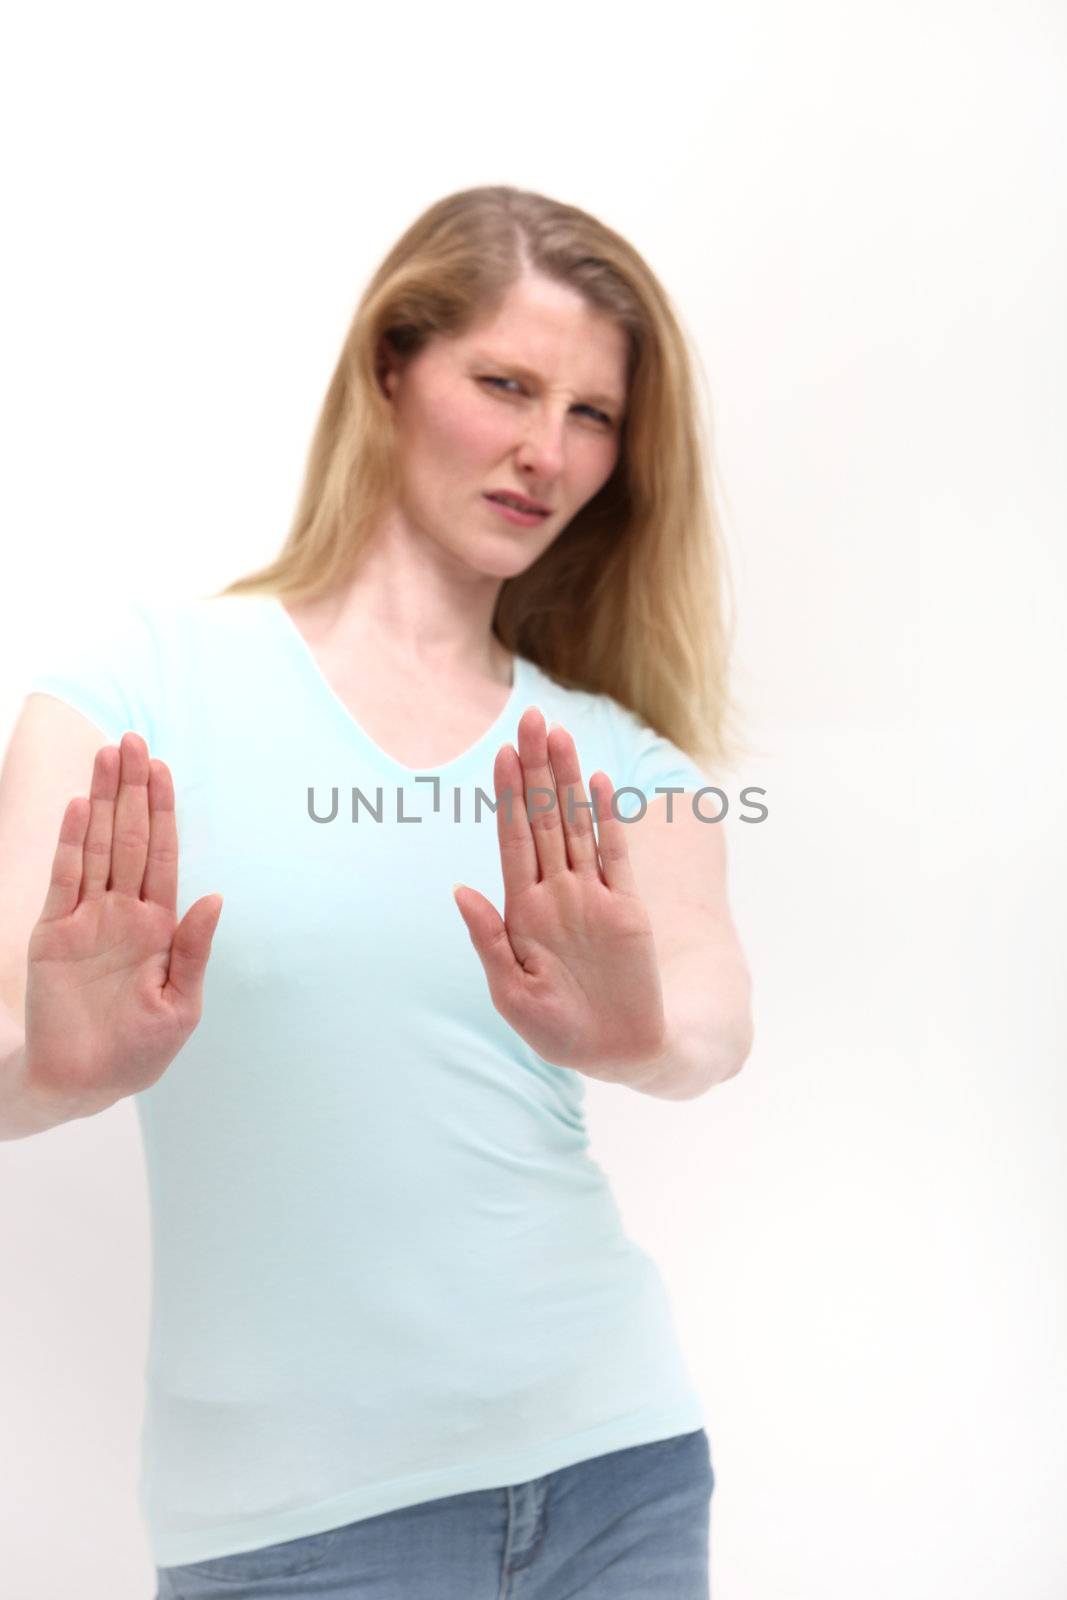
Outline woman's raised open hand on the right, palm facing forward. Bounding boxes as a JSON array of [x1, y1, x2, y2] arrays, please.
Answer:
[[453, 706, 665, 1082]]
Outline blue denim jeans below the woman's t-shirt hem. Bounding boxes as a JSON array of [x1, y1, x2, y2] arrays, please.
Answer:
[[155, 1427, 715, 1600]]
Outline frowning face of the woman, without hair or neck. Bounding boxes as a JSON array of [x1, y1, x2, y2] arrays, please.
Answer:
[[382, 274, 627, 578]]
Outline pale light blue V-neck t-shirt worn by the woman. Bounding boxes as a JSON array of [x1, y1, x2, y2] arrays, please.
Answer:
[[29, 595, 712, 1566]]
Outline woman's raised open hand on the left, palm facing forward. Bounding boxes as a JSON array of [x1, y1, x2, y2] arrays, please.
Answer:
[[24, 733, 222, 1115]]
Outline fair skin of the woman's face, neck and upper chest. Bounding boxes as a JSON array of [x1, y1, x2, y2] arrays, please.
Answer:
[[290, 268, 625, 768]]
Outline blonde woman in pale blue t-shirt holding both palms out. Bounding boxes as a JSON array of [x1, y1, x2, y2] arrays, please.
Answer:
[[0, 187, 752, 1600]]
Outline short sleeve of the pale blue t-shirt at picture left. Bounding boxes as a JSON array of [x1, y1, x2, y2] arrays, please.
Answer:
[[26, 603, 160, 752]]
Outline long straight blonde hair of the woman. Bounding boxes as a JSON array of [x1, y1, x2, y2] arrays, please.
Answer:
[[219, 184, 748, 766]]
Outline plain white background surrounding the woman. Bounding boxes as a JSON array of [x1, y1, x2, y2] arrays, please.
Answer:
[[0, 0, 1067, 1600]]
